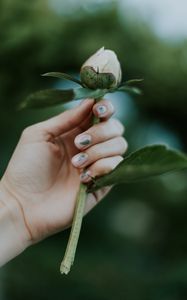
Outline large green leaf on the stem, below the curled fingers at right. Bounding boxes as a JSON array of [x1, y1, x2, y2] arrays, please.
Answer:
[[88, 145, 187, 191]]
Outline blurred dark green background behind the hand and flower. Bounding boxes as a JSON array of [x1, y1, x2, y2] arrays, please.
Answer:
[[0, 0, 187, 300]]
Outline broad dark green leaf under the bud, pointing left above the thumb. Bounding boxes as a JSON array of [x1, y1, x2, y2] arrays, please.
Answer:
[[19, 89, 75, 109]]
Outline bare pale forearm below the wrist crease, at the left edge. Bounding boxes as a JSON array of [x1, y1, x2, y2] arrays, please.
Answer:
[[0, 182, 29, 266]]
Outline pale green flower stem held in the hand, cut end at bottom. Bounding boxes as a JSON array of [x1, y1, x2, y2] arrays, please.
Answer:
[[60, 98, 100, 275]]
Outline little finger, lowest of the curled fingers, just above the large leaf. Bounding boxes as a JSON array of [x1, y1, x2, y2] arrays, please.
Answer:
[[80, 155, 123, 183]]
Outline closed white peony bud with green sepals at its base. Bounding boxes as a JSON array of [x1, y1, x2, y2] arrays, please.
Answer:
[[80, 47, 121, 89]]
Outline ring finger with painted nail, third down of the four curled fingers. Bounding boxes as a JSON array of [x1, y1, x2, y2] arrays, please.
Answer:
[[72, 136, 127, 168]]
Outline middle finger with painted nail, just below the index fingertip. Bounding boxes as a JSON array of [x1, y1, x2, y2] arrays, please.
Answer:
[[74, 119, 124, 150]]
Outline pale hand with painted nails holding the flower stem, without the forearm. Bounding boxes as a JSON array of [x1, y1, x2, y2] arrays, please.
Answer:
[[1, 99, 127, 248]]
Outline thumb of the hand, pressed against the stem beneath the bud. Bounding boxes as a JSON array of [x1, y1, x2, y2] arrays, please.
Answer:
[[39, 99, 94, 137]]
